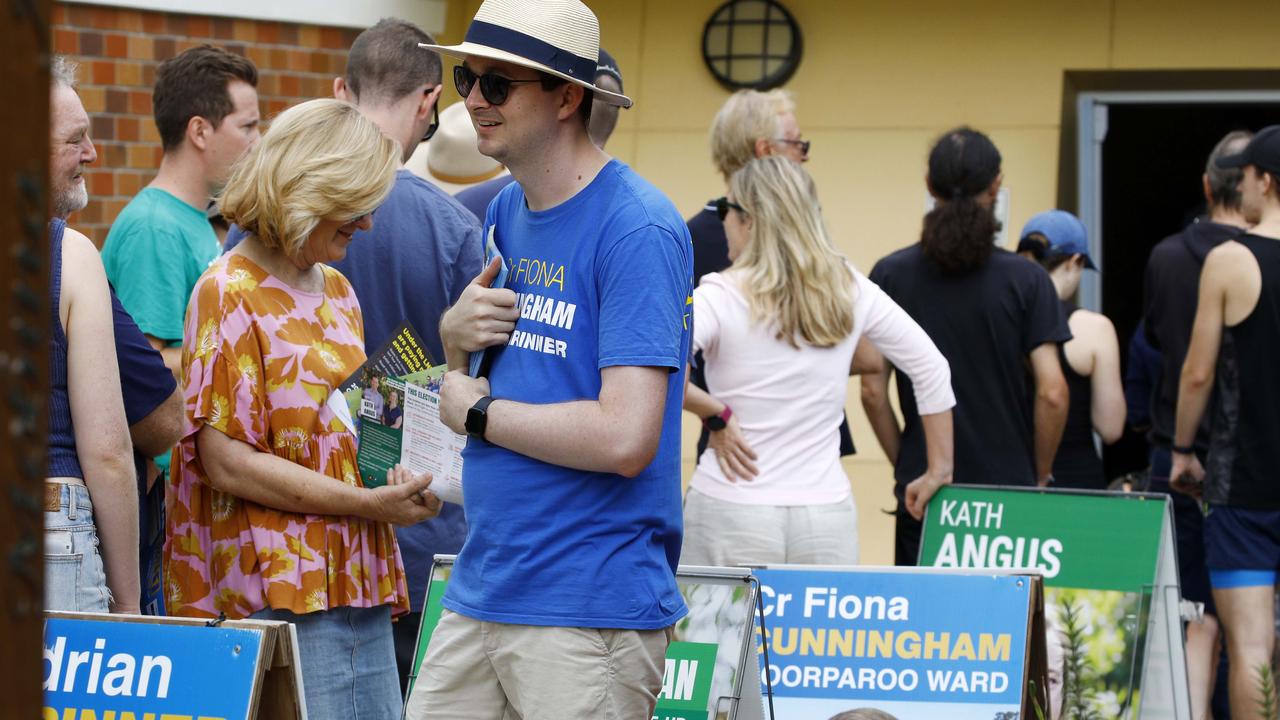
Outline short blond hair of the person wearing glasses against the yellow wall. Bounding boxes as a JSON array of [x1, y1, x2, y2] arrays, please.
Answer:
[[712, 90, 796, 178]]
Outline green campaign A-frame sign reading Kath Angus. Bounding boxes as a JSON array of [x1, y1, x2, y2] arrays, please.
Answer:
[[920, 486, 1185, 720]]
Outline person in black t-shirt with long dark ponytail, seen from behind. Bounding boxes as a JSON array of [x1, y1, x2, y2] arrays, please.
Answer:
[[863, 127, 1071, 565]]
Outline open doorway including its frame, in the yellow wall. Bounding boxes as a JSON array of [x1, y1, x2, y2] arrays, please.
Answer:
[[1060, 72, 1280, 477]]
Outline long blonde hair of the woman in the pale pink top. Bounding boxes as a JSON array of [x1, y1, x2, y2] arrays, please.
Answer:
[[728, 155, 854, 347]]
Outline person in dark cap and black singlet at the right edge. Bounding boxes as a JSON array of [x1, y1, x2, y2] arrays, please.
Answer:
[[1170, 126, 1280, 708]]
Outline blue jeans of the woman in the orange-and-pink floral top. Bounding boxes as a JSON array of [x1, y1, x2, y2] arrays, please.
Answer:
[[250, 605, 402, 720]]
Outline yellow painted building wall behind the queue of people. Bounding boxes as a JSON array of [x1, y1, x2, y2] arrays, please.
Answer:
[[444, 0, 1280, 564]]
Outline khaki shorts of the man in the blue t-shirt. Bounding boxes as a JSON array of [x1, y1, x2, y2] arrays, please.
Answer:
[[406, 610, 671, 720]]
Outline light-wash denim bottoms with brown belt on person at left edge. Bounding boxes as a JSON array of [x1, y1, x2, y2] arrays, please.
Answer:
[[45, 484, 111, 612]]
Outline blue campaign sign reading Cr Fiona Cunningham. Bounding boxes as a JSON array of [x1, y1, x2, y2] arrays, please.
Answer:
[[756, 568, 1033, 720]]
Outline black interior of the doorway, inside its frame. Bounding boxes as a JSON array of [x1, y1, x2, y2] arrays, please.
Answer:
[[1101, 104, 1280, 478]]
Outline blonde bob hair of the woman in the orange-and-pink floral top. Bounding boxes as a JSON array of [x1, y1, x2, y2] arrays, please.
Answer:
[[219, 100, 401, 256]]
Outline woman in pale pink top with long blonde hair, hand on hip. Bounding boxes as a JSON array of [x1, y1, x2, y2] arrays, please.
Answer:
[[681, 158, 955, 565]]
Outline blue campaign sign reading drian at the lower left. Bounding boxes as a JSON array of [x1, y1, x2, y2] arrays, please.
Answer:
[[44, 618, 264, 720]]
